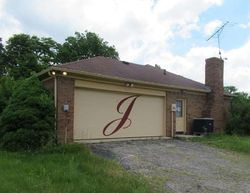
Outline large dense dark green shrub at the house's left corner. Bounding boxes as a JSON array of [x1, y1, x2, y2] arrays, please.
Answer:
[[0, 77, 54, 150]]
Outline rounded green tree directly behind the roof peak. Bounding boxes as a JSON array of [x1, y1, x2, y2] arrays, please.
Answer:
[[58, 31, 119, 63]]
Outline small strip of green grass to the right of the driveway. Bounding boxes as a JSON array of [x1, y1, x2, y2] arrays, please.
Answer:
[[192, 134, 250, 155]]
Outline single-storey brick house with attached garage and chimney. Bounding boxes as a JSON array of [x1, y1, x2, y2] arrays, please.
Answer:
[[38, 56, 230, 143]]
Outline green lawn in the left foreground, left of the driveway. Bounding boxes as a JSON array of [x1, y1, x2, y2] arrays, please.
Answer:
[[0, 145, 152, 193]]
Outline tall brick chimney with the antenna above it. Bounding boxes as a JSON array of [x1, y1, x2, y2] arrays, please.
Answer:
[[205, 57, 225, 132]]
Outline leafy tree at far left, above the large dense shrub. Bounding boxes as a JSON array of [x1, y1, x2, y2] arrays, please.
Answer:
[[1, 34, 59, 79]]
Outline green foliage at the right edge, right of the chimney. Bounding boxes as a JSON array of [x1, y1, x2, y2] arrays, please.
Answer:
[[226, 86, 250, 135]]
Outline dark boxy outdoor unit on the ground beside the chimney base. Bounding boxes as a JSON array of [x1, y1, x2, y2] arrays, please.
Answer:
[[192, 118, 214, 135]]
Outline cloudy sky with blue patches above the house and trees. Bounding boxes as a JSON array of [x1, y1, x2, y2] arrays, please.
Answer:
[[0, 0, 250, 93]]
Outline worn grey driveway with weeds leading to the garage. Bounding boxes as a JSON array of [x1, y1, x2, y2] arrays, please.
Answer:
[[89, 140, 250, 193]]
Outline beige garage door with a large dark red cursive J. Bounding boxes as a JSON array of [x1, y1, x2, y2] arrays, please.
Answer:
[[74, 88, 165, 140]]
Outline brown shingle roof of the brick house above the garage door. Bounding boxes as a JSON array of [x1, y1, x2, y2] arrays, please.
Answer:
[[57, 56, 210, 92]]
